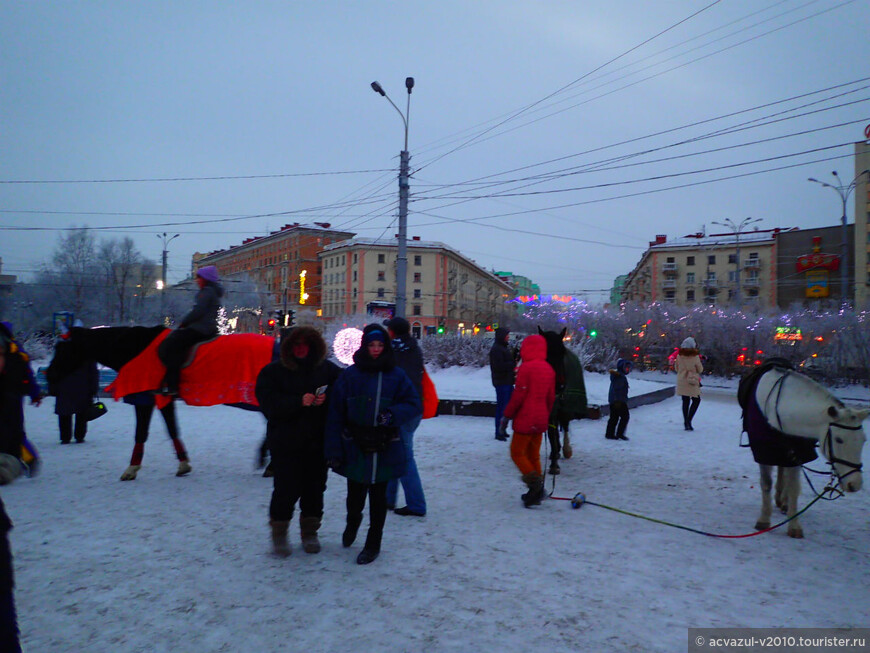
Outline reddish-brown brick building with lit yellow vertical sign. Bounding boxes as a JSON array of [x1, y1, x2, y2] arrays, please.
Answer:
[[191, 222, 354, 310]]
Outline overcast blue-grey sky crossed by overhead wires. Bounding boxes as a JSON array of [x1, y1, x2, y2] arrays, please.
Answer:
[[0, 0, 870, 301]]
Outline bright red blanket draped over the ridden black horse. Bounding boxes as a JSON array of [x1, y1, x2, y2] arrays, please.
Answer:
[[106, 329, 275, 408]]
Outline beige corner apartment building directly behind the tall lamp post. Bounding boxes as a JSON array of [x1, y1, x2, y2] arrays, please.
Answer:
[[320, 238, 514, 337]]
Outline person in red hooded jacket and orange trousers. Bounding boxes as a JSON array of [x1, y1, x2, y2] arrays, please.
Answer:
[[502, 334, 556, 508]]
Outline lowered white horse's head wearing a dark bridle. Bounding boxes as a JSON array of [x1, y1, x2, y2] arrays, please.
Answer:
[[820, 402, 870, 492]]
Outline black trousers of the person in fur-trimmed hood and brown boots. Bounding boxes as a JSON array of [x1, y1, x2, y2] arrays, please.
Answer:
[[269, 455, 328, 521]]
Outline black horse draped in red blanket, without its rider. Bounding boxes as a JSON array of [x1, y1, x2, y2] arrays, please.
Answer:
[[46, 326, 275, 481]]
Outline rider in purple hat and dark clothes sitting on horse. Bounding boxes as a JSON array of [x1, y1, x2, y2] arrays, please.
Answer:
[[157, 265, 224, 395]]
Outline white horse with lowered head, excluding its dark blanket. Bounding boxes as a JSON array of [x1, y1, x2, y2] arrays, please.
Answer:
[[744, 367, 870, 538]]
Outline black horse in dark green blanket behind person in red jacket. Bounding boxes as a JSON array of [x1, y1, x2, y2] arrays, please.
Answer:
[[538, 327, 587, 474]]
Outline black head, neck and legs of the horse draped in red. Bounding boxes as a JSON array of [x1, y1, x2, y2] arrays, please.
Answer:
[[46, 326, 192, 481]]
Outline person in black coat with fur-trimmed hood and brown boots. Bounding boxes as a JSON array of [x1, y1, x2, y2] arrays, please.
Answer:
[[255, 327, 341, 556]]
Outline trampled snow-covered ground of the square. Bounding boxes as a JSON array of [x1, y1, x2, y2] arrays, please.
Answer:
[[2, 369, 870, 653]]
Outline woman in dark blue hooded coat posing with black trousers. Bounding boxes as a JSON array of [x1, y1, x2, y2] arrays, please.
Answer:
[[325, 324, 422, 565]]
